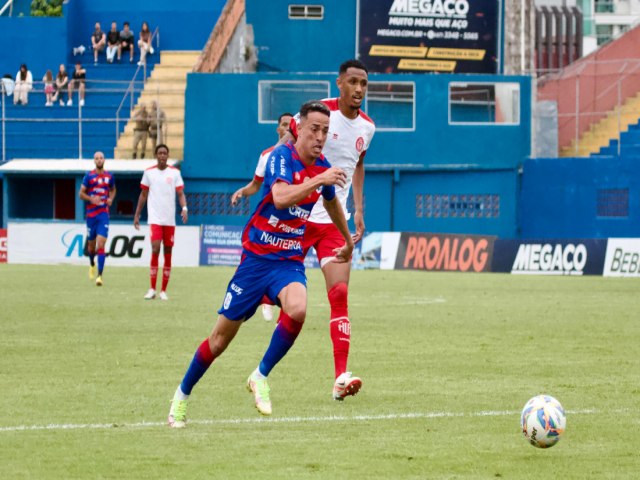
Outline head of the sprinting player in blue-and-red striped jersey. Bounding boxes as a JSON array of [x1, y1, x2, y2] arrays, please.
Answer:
[[296, 100, 331, 161]]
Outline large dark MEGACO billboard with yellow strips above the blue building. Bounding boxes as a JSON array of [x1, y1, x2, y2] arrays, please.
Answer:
[[357, 0, 501, 73]]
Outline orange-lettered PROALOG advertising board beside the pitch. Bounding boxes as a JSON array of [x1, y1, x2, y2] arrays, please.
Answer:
[[395, 232, 495, 272]]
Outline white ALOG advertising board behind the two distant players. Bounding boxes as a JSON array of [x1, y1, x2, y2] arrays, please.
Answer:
[[8, 223, 200, 267]]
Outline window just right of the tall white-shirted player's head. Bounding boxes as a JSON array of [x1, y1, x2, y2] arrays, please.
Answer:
[[365, 82, 416, 131]]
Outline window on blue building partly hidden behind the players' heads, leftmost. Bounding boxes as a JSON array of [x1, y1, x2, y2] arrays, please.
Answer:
[[258, 80, 329, 123]]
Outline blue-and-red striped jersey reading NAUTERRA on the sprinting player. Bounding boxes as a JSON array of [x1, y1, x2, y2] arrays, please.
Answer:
[[242, 143, 335, 263]]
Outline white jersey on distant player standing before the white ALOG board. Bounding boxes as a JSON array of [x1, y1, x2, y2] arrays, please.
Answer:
[[140, 165, 184, 226]]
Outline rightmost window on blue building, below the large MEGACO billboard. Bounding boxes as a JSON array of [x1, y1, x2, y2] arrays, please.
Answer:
[[449, 83, 520, 125]]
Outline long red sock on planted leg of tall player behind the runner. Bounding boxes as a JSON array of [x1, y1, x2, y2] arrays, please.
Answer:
[[328, 282, 351, 378]]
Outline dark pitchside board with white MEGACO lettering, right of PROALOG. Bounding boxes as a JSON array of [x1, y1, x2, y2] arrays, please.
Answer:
[[493, 239, 607, 275]]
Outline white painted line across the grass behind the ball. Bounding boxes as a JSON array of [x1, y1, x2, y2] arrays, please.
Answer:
[[0, 409, 597, 433]]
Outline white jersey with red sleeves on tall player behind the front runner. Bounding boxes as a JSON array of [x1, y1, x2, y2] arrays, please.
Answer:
[[290, 98, 376, 223]]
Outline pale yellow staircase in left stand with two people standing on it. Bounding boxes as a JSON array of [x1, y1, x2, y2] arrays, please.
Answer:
[[115, 51, 200, 160]]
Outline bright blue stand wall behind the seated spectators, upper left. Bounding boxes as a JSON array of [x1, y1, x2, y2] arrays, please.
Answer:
[[0, 0, 226, 80]]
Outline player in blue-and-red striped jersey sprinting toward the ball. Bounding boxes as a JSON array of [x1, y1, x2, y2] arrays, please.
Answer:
[[168, 102, 353, 428]]
